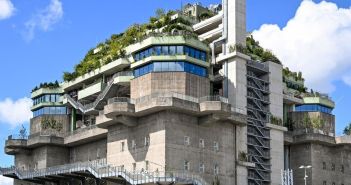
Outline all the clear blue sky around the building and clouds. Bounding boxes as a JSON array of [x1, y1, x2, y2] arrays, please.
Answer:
[[0, 0, 351, 166]]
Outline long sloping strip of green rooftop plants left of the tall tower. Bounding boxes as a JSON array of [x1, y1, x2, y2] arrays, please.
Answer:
[[63, 9, 196, 81]]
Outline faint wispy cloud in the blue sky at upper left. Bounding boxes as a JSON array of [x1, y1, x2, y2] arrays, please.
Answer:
[[24, 0, 63, 41]]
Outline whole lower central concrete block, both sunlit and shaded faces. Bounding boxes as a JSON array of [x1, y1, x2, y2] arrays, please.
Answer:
[[107, 111, 243, 185]]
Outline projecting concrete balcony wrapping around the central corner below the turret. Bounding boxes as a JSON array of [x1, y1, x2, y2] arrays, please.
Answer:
[[97, 92, 247, 128]]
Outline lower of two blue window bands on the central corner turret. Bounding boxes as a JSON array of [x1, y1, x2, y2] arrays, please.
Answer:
[[134, 61, 207, 78]]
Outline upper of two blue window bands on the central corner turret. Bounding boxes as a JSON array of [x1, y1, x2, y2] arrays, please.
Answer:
[[134, 45, 207, 62]]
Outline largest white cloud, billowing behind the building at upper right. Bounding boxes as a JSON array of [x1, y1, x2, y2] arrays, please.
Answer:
[[253, 0, 351, 92]]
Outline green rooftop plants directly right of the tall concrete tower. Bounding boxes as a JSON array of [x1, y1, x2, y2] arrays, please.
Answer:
[[229, 36, 282, 64]]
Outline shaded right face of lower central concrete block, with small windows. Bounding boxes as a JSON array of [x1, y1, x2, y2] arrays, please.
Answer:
[[164, 112, 236, 185]]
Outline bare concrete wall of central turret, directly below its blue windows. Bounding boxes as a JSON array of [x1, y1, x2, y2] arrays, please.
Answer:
[[131, 72, 210, 99]]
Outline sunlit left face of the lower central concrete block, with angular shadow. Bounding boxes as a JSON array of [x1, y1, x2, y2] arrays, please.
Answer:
[[107, 112, 166, 171]]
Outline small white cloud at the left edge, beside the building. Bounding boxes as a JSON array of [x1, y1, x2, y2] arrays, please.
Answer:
[[0, 97, 32, 127]]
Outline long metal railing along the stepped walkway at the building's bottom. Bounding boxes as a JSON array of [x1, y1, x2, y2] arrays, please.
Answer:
[[0, 159, 208, 185]]
